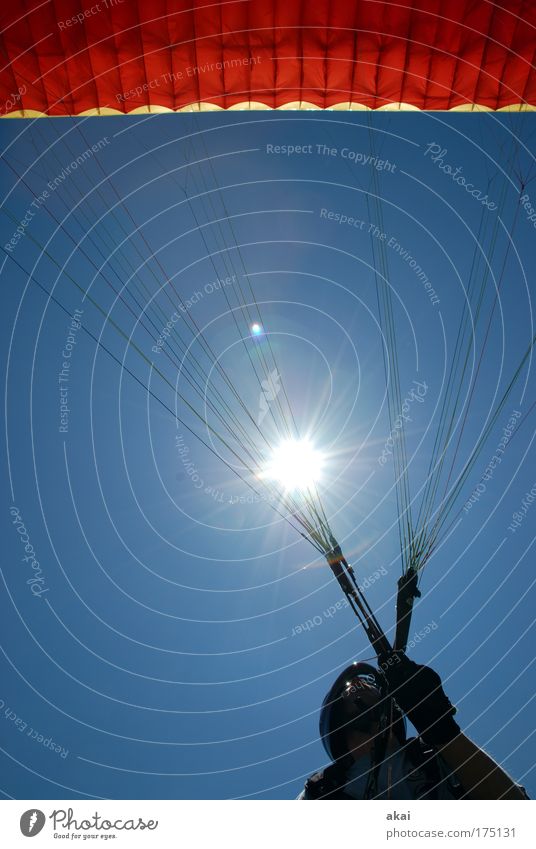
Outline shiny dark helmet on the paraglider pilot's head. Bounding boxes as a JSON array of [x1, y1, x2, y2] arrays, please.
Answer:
[[319, 662, 406, 761]]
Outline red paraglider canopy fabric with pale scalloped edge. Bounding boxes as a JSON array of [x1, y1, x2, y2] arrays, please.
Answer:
[[0, 0, 536, 115]]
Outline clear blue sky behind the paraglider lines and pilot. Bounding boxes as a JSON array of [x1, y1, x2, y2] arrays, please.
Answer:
[[0, 112, 536, 799]]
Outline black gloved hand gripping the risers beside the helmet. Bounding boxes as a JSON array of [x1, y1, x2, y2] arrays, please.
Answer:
[[382, 652, 460, 747]]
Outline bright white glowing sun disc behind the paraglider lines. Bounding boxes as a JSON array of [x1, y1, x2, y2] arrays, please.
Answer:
[[262, 439, 323, 492]]
